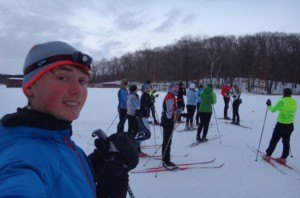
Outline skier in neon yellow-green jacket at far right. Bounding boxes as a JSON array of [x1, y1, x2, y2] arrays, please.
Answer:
[[264, 88, 297, 164]]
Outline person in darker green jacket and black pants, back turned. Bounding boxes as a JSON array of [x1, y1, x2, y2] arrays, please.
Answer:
[[196, 85, 217, 142]]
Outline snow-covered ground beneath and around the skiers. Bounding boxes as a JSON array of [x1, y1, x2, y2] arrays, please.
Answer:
[[0, 87, 300, 198]]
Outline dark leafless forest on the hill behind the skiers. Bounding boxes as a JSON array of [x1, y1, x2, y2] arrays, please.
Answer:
[[92, 32, 300, 83]]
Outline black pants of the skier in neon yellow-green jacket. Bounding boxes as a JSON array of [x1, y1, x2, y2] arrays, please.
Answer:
[[266, 122, 294, 159]]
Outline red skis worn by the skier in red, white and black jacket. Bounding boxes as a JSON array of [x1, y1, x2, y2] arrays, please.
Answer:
[[131, 158, 225, 174]]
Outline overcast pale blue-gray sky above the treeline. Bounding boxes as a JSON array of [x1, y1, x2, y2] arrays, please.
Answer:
[[0, 0, 300, 74]]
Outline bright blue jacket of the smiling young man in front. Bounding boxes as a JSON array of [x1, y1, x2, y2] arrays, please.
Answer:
[[0, 125, 96, 198]]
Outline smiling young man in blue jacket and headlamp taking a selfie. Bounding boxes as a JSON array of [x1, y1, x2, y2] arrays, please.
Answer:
[[0, 41, 138, 197]]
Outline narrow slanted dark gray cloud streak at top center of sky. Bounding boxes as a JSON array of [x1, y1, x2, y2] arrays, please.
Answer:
[[154, 9, 181, 32]]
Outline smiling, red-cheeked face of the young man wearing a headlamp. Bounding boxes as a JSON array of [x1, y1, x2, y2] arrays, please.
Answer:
[[25, 65, 90, 121]]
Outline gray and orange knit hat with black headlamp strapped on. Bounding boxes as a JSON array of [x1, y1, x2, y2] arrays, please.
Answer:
[[22, 41, 93, 92]]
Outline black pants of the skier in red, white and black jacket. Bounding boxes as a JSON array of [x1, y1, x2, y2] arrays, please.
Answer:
[[162, 118, 174, 162]]
